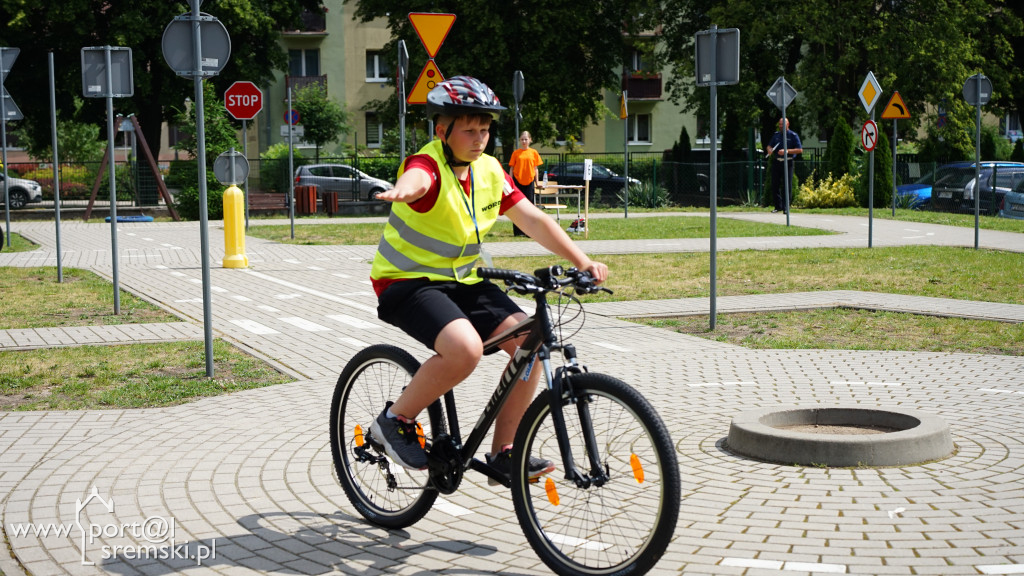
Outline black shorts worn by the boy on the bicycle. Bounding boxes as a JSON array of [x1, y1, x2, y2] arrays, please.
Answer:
[[377, 279, 522, 349]]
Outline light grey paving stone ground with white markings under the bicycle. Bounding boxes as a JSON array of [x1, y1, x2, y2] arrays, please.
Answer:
[[0, 213, 1024, 576]]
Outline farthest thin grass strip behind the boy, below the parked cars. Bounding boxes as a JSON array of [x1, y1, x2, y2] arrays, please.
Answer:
[[247, 212, 833, 245]]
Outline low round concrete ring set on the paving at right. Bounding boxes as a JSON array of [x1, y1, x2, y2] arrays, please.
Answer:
[[726, 406, 953, 467]]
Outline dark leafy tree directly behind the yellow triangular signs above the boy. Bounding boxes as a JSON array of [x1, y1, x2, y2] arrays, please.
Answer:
[[355, 0, 654, 155]]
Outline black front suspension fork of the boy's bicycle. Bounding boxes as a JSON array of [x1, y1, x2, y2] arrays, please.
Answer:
[[539, 344, 608, 488]]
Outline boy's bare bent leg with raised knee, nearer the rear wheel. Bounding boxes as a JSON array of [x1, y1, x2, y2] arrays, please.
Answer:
[[391, 319, 483, 420]]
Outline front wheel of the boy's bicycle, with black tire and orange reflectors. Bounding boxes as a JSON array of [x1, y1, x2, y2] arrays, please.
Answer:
[[512, 373, 681, 576]]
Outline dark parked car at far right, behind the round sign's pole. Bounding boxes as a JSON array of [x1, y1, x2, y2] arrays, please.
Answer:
[[932, 162, 1024, 215]]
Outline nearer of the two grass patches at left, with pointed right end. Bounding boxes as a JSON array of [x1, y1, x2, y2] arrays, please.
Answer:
[[0, 340, 290, 410]]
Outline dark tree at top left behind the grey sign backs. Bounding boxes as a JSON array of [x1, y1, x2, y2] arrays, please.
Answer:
[[0, 0, 323, 156]]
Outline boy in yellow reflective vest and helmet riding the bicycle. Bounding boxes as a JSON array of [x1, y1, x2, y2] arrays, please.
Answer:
[[371, 76, 608, 478]]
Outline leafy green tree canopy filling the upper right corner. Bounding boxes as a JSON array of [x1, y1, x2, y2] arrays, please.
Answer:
[[657, 0, 1024, 151]]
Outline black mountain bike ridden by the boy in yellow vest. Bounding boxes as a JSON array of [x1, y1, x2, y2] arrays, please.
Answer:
[[330, 266, 680, 576]]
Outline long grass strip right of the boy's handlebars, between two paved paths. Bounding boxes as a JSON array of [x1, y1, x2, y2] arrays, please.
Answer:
[[495, 246, 1024, 304]]
